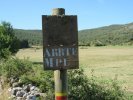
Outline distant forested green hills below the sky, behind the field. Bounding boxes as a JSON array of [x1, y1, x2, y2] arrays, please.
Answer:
[[15, 23, 133, 46]]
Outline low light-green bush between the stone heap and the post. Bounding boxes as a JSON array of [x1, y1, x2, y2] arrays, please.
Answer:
[[20, 66, 54, 93]]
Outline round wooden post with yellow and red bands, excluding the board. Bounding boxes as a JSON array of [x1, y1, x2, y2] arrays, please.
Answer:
[[52, 8, 68, 100]]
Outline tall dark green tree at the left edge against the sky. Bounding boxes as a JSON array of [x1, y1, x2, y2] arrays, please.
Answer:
[[0, 22, 19, 59]]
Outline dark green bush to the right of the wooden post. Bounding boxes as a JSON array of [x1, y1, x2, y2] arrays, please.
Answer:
[[68, 69, 126, 100]]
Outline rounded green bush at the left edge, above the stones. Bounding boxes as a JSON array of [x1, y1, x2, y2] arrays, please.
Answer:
[[0, 58, 32, 78]]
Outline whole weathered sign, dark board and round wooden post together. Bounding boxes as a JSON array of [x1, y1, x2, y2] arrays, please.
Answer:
[[42, 8, 79, 100]]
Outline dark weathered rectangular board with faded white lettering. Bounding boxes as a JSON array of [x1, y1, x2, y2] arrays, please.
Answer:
[[42, 15, 79, 70]]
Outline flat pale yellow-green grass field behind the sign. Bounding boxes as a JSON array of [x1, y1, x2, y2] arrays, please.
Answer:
[[16, 46, 133, 92]]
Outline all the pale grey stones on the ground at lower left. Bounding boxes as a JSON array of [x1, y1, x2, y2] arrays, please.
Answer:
[[0, 79, 46, 100]]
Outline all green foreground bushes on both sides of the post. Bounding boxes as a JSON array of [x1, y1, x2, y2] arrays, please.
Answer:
[[0, 58, 127, 100]]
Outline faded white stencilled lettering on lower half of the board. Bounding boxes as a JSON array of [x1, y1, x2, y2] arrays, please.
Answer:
[[45, 47, 78, 67]]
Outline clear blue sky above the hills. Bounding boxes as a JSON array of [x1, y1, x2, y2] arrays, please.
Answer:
[[0, 0, 133, 30]]
